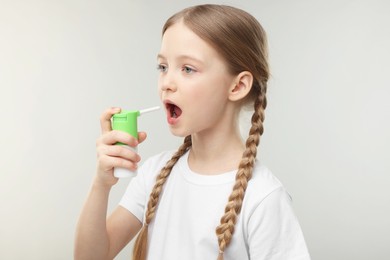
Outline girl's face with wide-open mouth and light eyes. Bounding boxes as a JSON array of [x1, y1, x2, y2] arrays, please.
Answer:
[[157, 22, 235, 136]]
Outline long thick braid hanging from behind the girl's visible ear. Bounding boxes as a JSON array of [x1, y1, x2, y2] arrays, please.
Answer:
[[216, 83, 267, 260]]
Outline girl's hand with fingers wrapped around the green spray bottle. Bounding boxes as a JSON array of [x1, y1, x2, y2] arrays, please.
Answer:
[[96, 108, 146, 187]]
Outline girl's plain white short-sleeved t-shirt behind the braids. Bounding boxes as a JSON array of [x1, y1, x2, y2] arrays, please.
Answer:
[[120, 152, 310, 260]]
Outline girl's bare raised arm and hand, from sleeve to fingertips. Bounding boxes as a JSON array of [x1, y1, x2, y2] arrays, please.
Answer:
[[74, 108, 146, 260]]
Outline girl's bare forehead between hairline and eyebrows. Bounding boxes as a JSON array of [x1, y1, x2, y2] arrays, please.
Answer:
[[160, 21, 219, 61]]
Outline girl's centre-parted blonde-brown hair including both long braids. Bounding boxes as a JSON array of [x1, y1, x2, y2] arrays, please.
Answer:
[[133, 4, 269, 260]]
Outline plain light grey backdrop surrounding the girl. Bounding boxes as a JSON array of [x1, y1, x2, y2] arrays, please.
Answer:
[[0, 0, 390, 260]]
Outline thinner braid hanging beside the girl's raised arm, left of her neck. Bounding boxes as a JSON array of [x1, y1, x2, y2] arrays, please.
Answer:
[[133, 136, 192, 260]]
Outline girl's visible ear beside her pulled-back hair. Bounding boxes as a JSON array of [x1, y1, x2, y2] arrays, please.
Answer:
[[229, 71, 253, 101]]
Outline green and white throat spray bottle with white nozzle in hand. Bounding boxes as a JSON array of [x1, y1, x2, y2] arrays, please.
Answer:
[[112, 107, 160, 178]]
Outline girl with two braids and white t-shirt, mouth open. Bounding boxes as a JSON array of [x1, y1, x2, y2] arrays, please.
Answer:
[[75, 5, 310, 260]]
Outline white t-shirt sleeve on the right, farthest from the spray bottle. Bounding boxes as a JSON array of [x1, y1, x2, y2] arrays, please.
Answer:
[[248, 187, 310, 260]]
